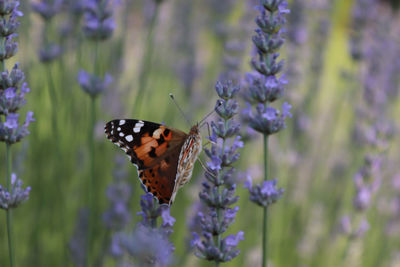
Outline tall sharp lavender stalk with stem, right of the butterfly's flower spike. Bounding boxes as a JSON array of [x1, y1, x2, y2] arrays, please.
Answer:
[[242, 0, 292, 267]]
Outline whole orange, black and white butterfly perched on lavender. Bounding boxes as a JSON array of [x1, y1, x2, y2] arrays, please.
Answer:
[[104, 119, 202, 205]]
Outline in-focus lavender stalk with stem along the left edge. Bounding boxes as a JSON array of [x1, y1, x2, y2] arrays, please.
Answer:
[[0, 0, 33, 267]]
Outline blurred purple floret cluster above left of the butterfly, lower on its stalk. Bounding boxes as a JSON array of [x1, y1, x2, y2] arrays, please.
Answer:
[[78, 70, 112, 97]]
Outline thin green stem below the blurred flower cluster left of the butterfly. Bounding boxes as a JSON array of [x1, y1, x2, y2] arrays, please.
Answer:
[[87, 96, 96, 266]]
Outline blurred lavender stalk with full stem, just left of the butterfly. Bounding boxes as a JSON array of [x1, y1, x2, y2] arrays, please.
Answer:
[[78, 0, 115, 266]]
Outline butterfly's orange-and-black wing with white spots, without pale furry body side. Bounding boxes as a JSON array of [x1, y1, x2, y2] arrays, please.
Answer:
[[105, 119, 187, 204]]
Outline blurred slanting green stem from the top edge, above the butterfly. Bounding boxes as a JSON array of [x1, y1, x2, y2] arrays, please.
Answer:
[[133, 2, 160, 115]]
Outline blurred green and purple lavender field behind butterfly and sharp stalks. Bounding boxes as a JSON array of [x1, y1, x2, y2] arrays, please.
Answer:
[[0, 0, 400, 267]]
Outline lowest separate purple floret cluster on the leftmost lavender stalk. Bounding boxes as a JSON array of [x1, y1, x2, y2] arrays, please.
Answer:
[[0, 173, 31, 210]]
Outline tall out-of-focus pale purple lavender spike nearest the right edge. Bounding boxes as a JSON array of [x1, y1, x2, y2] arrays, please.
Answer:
[[345, 1, 394, 244]]
